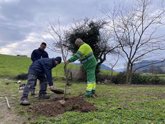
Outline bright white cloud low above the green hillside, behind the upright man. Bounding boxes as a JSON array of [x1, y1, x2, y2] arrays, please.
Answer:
[[0, 32, 61, 58]]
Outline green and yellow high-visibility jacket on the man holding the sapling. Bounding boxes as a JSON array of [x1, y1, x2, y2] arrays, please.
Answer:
[[68, 43, 97, 69]]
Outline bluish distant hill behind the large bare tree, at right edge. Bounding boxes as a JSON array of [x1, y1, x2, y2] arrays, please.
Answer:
[[134, 60, 165, 73]]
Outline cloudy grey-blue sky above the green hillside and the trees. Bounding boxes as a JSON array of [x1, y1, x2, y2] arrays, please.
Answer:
[[0, 0, 164, 69]]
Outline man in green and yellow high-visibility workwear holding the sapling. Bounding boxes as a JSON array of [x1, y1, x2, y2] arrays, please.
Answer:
[[65, 38, 97, 97]]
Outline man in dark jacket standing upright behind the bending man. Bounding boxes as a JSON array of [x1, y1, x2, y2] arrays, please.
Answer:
[[31, 42, 49, 95]]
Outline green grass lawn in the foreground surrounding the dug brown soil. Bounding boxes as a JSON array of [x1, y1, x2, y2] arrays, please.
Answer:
[[0, 79, 165, 124]]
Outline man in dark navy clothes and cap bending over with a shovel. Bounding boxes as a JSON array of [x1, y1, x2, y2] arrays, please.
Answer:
[[20, 57, 61, 105]]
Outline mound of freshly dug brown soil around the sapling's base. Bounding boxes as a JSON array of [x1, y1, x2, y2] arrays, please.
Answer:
[[29, 96, 96, 116]]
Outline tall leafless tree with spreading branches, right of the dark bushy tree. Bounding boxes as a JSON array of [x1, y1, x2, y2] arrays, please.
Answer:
[[108, 0, 165, 83]]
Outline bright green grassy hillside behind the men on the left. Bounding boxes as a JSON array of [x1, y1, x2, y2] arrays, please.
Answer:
[[0, 54, 78, 78]]
